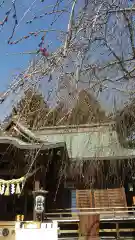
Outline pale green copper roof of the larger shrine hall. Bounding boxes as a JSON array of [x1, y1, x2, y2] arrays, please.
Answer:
[[35, 123, 135, 159]]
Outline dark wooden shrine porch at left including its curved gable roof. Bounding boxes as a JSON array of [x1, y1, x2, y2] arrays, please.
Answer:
[[0, 121, 66, 220]]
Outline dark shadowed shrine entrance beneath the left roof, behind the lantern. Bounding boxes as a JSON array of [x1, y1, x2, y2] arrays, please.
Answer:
[[0, 140, 66, 221]]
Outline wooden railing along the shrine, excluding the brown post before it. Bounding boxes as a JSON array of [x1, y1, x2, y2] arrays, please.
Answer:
[[47, 207, 135, 240]]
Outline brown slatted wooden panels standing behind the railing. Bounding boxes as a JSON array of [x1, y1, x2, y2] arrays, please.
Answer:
[[76, 187, 128, 217]]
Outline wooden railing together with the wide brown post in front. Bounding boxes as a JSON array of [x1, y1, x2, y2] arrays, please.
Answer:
[[47, 207, 135, 240]]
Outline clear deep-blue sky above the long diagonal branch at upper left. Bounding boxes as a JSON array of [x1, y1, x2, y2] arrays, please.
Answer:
[[0, 0, 71, 92]]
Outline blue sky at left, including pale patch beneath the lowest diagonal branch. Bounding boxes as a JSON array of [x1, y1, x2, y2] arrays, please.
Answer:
[[0, 0, 82, 120]]
